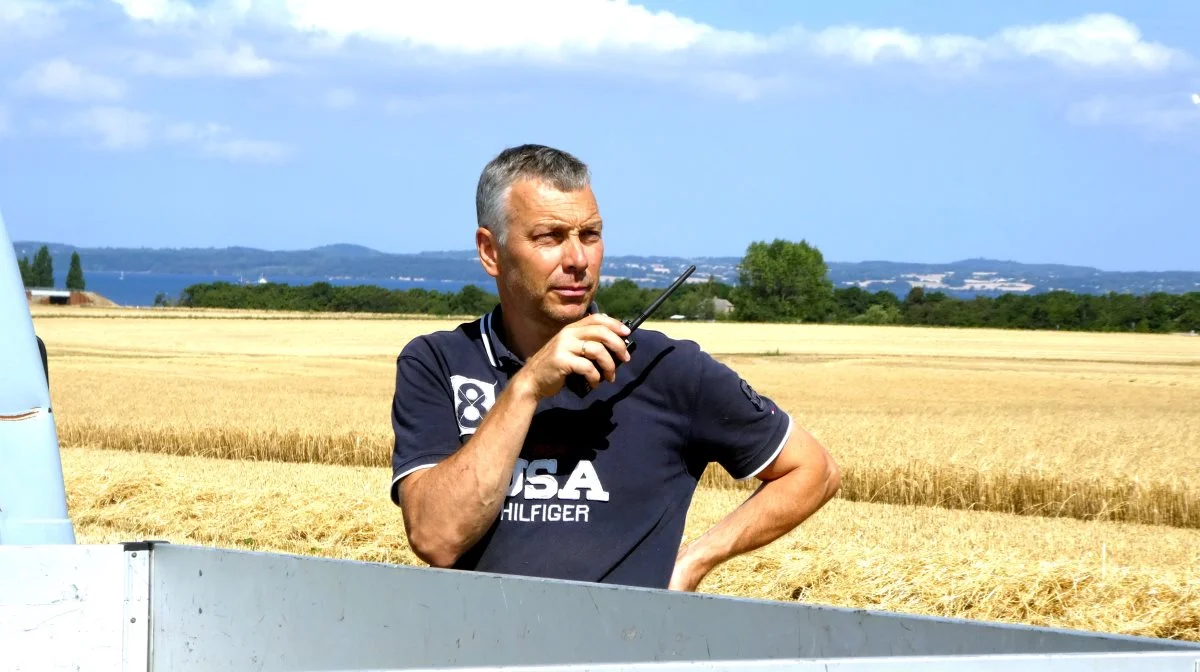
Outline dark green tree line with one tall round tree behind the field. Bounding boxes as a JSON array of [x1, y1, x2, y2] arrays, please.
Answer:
[[171, 239, 1200, 332]]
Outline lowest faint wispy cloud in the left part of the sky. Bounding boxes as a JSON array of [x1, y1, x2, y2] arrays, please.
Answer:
[[58, 106, 292, 163]]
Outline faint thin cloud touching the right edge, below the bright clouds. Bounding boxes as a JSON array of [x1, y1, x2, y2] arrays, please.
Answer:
[[1067, 94, 1200, 137]]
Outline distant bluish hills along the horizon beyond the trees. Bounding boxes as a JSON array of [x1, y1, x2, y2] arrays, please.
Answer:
[[13, 241, 1200, 296]]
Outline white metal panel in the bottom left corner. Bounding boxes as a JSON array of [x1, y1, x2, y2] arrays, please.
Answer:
[[0, 545, 126, 672]]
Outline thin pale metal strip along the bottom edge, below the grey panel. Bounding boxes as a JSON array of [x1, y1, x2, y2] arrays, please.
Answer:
[[356, 653, 1200, 672]]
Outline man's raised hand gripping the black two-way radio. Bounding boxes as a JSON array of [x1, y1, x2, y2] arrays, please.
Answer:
[[514, 314, 629, 398]]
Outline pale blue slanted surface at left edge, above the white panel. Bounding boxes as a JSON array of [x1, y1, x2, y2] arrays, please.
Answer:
[[0, 208, 74, 545]]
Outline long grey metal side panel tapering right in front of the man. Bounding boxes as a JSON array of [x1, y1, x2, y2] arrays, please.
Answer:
[[151, 545, 1200, 670]]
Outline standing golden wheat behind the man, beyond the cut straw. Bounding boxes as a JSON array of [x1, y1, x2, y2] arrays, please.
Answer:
[[35, 308, 1200, 528]]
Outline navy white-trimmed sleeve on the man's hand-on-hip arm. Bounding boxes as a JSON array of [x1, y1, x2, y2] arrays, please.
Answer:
[[691, 350, 792, 480]]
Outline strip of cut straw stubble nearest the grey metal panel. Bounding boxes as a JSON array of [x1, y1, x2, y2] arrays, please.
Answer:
[[62, 449, 1200, 641]]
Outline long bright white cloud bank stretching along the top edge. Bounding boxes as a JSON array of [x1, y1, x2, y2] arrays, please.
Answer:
[[105, 0, 1187, 71]]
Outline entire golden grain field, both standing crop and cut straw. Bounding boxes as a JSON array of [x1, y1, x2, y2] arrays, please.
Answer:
[[34, 308, 1200, 640]]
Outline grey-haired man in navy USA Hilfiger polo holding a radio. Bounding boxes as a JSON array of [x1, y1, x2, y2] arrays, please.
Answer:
[[391, 145, 839, 590]]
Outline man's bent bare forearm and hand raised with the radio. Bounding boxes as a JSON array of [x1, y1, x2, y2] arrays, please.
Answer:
[[398, 316, 629, 566]]
